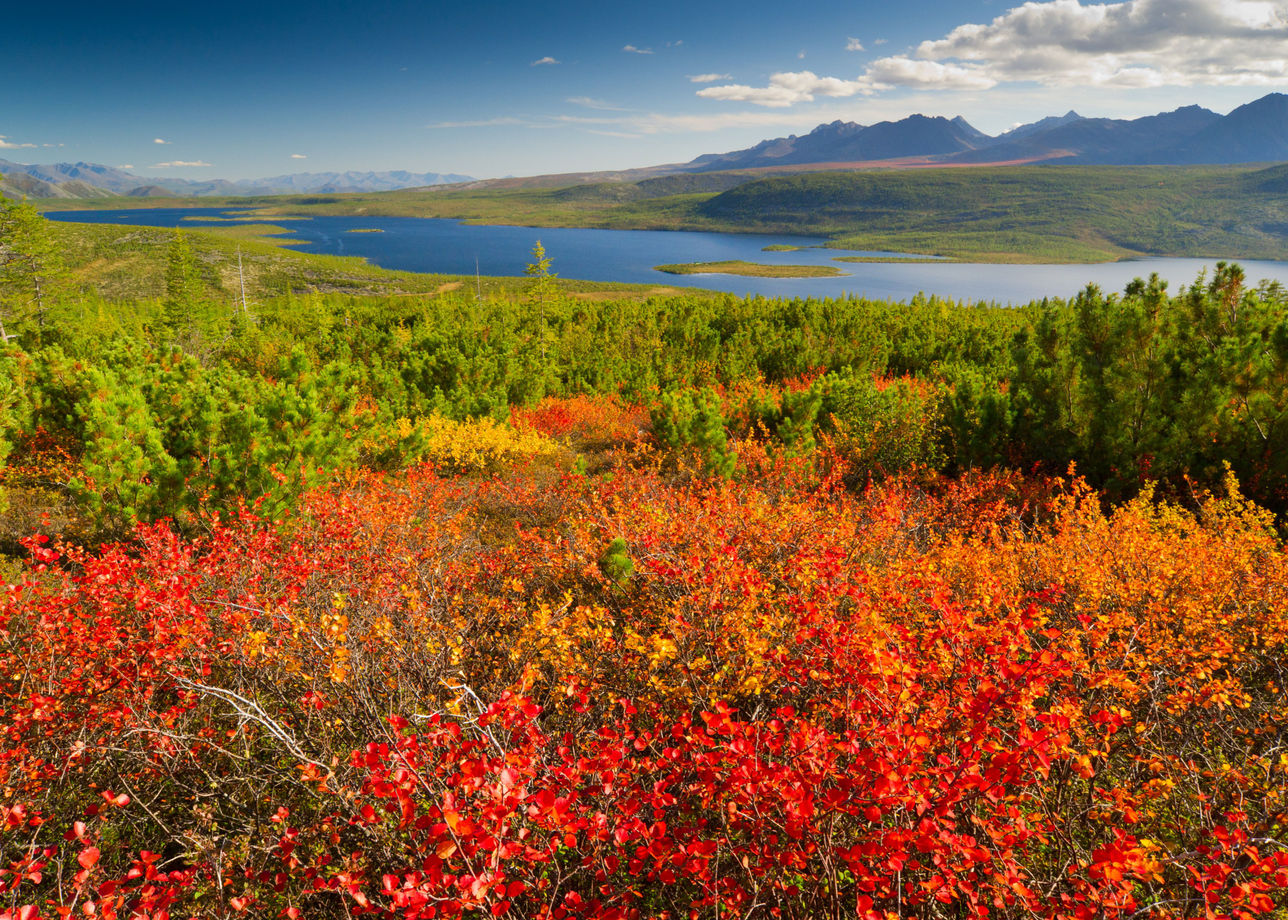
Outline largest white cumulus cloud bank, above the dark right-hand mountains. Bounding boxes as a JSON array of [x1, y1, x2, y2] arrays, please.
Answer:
[[698, 0, 1288, 107]]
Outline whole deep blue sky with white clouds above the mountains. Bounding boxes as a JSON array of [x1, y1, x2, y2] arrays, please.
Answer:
[[0, 0, 1288, 179]]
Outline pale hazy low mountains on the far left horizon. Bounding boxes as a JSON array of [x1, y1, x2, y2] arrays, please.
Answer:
[[0, 160, 471, 198]]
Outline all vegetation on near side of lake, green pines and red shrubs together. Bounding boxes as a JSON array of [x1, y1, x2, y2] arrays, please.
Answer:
[[0, 197, 1288, 920]]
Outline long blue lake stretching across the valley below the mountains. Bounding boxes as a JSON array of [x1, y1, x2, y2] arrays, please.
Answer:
[[48, 207, 1288, 304]]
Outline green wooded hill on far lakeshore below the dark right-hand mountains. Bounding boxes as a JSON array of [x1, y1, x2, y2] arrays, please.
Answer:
[[696, 166, 1288, 260]]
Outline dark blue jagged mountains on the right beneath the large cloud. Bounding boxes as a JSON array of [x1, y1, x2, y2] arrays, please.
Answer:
[[680, 93, 1288, 171]]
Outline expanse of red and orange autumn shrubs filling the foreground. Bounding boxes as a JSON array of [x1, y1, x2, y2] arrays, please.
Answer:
[[0, 465, 1288, 920]]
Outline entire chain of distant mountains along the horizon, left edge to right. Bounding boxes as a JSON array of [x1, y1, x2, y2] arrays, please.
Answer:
[[0, 93, 1288, 198]]
